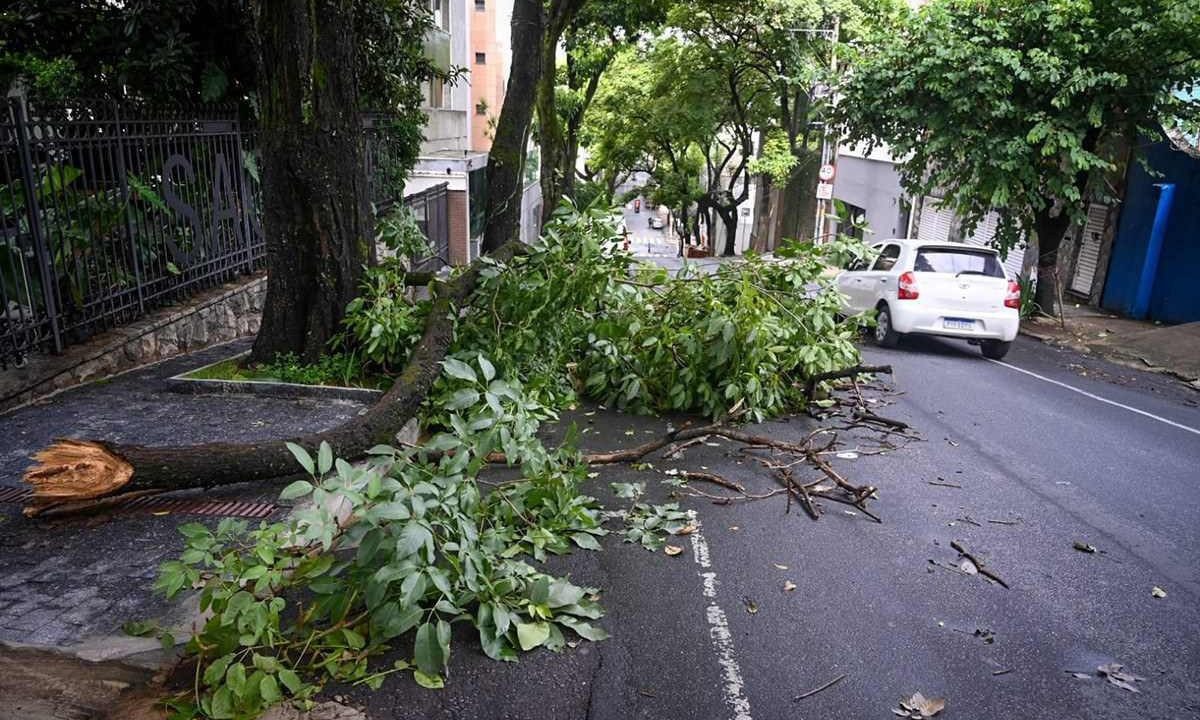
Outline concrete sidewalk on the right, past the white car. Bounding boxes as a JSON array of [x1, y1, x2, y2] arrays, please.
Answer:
[[1021, 307, 1200, 390]]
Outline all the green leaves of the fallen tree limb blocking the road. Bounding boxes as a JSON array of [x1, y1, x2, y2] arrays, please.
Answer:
[[156, 205, 864, 719]]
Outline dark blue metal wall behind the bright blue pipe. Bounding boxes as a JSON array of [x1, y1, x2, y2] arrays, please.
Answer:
[[1100, 143, 1200, 323]]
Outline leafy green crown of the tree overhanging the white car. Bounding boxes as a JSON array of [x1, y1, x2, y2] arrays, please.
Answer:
[[839, 0, 1200, 252]]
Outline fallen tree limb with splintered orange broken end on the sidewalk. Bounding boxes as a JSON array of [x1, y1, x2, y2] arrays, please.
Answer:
[[25, 240, 524, 515]]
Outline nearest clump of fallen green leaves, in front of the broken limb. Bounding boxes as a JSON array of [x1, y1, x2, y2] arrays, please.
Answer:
[[156, 356, 606, 719]]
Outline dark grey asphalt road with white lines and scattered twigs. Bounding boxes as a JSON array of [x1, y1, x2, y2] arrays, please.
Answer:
[[334, 338, 1200, 720]]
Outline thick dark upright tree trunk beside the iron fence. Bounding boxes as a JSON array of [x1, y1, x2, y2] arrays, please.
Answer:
[[251, 0, 372, 362]]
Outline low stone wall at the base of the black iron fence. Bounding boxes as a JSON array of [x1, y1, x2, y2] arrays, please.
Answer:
[[0, 275, 266, 413]]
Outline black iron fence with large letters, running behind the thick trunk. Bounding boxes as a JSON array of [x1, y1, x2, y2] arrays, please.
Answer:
[[0, 98, 445, 367]]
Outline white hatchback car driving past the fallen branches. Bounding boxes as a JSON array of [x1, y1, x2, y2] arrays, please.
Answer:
[[836, 240, 1021, 360]]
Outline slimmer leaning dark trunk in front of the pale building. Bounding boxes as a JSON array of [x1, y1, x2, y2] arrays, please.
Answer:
[[482, 0, 546, 252]]
